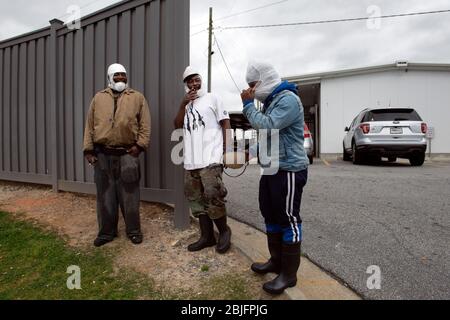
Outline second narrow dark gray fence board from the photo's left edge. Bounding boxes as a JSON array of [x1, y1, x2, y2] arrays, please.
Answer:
[[11, 45, 19, 172]]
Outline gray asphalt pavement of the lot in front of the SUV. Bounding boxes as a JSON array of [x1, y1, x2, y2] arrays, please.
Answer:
[[224, 159, 450, 299]]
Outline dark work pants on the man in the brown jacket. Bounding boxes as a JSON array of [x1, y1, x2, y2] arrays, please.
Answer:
[[95, 153, 142, 240]]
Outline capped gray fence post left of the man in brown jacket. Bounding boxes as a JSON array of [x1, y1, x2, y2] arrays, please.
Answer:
[[48, 19, 64, 192]]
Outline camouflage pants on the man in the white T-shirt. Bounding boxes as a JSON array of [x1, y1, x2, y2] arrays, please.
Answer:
[[184, 165, 228, 220]]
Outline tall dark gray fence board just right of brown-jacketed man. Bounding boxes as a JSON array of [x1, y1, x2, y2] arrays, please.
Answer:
[[145, 1, 164, 188]]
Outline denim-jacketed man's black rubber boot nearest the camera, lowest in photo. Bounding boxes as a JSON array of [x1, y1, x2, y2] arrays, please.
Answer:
[[263, 242, 301, 294]]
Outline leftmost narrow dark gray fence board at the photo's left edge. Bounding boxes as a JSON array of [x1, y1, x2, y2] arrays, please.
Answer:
[[3, 48, 11, 172]]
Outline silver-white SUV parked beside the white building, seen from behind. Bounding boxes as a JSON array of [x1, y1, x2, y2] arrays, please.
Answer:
[[343, 108, 427, 166]]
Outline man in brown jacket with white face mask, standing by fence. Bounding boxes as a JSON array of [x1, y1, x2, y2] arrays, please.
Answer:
[[83, 64, 150, 247]]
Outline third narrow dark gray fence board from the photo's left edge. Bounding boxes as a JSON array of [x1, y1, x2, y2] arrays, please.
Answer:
[[26, 40, 37, 173]]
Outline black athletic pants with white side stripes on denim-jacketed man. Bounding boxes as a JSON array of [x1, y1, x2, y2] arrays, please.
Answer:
[[259, 169, 308, 243]]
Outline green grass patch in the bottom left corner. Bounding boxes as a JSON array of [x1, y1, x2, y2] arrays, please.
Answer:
[[0, 212, 176, 300]]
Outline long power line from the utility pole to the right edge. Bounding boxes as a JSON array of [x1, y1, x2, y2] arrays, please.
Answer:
[[220, 9, 450, 30]]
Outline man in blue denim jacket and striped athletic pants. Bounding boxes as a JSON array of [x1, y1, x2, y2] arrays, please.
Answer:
[[241, 62, 308, 294]]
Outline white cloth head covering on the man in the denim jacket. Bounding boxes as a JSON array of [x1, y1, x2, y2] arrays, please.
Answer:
[[246, 61, 281, 102]]
